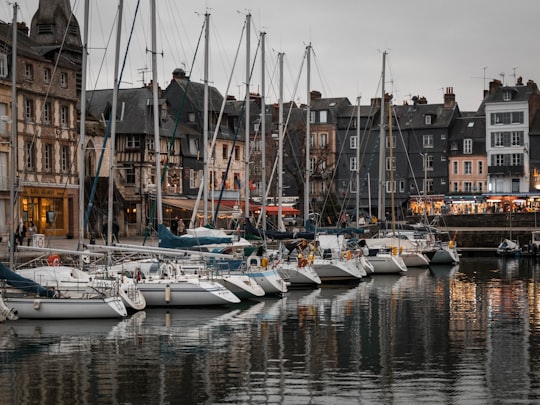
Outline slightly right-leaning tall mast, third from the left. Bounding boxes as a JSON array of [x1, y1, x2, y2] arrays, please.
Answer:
[[107, 0, 122, 249]]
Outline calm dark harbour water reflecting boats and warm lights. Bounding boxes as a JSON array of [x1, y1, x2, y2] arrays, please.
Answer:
[[0, 258, 540, 405]]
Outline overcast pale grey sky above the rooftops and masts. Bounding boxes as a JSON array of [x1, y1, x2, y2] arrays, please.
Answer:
[[4, 0, 540, 111]]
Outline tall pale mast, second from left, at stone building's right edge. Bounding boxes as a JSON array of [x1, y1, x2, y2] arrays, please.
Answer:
[[79, 0, 90, 248]]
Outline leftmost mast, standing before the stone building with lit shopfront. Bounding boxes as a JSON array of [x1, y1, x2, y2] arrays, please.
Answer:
[[9, 3, 19, 269]]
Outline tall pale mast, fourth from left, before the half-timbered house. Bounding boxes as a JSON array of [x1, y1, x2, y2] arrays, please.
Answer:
[[150, 0, 163, 224]]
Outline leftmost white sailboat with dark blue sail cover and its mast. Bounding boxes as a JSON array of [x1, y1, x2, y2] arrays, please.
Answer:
[[0, 4, 127, 319]]
